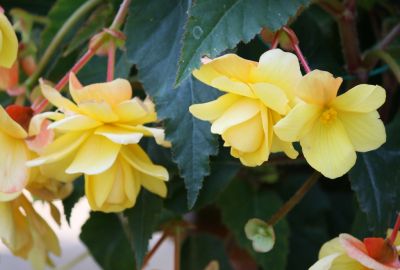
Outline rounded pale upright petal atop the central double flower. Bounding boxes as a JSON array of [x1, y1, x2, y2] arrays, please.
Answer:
[[251, 49, 301, 100]]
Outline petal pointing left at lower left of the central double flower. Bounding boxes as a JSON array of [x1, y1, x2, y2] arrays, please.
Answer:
[[189, 94, 240, 122]]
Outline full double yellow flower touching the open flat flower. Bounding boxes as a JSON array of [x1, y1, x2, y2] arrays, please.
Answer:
[[189, 49, 301, 166]]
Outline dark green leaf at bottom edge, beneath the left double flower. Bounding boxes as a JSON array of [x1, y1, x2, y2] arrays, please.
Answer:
[[80, 212, 136, 270]]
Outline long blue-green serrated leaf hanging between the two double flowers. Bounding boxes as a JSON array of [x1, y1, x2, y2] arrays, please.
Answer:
[[125, 0, 218, 207]]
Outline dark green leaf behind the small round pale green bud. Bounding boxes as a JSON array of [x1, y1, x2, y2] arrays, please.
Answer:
[[218, 179, 289, 270]]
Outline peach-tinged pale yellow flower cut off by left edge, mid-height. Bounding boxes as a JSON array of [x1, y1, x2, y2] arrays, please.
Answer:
[[0, 106, 30, 201]]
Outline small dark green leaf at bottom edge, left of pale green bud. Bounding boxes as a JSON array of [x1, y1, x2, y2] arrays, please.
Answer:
[[181, 233, 232, 270]]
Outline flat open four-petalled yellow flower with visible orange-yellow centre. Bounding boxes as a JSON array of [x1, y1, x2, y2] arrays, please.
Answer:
[[274, 70, 386, 178]]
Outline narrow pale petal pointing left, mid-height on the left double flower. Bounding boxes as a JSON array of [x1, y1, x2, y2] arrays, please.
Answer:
[[48, 114, 102, 131]]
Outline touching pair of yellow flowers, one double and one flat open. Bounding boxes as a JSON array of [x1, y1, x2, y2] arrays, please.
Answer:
[[190, 49, 386, 178]]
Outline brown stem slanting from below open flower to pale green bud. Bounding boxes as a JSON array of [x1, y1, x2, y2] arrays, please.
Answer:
[[267, 171, 321, 226]]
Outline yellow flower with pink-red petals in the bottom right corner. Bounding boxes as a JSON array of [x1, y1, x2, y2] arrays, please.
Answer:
[[309, 234, 400, 270]]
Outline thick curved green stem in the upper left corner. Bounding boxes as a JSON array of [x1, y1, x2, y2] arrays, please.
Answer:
[[25, 0, 103, 89]]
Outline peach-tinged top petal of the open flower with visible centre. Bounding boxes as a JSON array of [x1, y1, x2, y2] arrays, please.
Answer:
[[296, 70, 342, 106]]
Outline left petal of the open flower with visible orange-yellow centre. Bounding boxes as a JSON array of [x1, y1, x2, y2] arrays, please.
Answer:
[[274, 103, 322, 142]]
